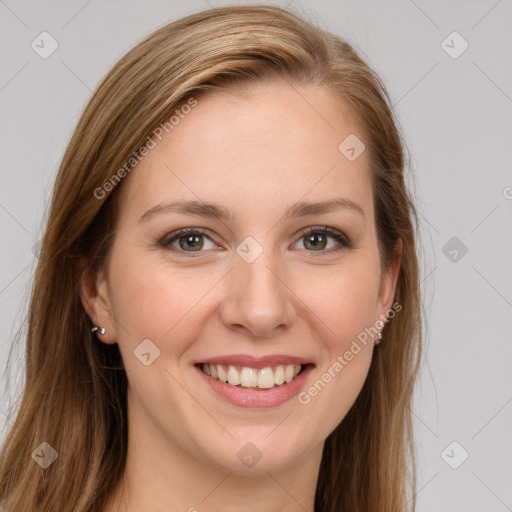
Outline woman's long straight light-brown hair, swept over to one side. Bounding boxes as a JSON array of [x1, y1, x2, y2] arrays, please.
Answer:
[[0, 5, 422, 512]]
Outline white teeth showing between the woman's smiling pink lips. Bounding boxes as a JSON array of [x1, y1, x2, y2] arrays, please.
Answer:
[[197, 363, 311, 390]]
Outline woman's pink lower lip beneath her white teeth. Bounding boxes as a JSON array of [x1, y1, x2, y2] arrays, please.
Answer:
[[196, 365, 313, 407]]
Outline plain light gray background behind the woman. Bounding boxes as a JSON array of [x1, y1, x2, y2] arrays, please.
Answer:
[[0, 0, 512, 512]]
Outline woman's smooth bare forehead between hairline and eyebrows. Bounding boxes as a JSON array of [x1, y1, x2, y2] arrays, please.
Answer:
[[116, 82, 373, 224]]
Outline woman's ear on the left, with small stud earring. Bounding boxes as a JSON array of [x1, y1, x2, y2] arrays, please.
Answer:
[[77, 258, 117, 345]]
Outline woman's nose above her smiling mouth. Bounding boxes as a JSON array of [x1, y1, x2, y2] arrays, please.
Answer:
[[220, 251, 296, 339]]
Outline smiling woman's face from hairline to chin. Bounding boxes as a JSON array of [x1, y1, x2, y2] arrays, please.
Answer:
[[86, 82, 398, 472]]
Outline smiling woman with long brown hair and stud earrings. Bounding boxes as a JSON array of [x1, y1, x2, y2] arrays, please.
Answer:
[[0, 6, 421, 512]]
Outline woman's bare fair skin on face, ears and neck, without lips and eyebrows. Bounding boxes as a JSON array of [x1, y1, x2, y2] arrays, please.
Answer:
[[81, 82, 400, 512]]
